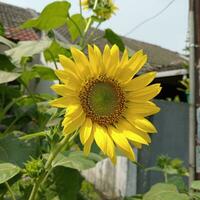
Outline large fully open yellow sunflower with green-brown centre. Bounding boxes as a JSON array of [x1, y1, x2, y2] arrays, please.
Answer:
[[51, 45, 161, 163]]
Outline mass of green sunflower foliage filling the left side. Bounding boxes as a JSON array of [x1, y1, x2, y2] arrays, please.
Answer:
[[0, 1, 122, 200]]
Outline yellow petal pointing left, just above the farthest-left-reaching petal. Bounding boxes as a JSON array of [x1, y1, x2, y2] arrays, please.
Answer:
[[51, 84, 77, 97]]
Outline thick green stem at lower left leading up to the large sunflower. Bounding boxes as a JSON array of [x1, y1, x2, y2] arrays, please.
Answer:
[[28, 135, 69, 200]]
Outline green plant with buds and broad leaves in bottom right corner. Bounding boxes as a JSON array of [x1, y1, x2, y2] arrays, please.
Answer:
[[125, 155, 200, 200]]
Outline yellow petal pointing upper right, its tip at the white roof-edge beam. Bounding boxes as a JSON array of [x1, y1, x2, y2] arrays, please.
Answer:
[[124, 72, 156, 91]]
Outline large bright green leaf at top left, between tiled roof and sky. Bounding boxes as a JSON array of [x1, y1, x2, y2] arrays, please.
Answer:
[[21, 1, 71, 31]]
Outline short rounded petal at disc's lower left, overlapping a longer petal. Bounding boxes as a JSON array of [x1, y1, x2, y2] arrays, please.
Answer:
[[80, 118, 92, 144]]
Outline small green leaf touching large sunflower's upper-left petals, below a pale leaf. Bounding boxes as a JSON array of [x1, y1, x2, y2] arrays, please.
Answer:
[[33, 65, 58, 81]]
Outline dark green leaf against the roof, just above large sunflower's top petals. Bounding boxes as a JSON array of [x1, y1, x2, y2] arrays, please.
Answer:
[[104, 29, 125, 51]]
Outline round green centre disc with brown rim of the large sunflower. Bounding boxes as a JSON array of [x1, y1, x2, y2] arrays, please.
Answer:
[[79, 76, 125, 126]]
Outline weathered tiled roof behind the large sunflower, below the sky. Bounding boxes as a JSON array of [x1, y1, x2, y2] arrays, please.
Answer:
[[0, 2, 187, 72]]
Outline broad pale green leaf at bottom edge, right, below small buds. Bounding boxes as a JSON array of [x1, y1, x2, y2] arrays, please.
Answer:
[[143, 183, 189, 200]]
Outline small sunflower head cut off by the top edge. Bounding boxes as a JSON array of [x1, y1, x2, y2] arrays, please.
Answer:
[[82, 0, 118, 20]]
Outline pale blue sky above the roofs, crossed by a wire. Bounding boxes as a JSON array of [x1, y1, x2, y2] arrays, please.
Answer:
[[0, 0, 188, 53]]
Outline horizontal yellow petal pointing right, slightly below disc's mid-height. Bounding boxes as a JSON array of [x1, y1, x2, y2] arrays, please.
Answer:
[[126, 101, 160, 117]]
